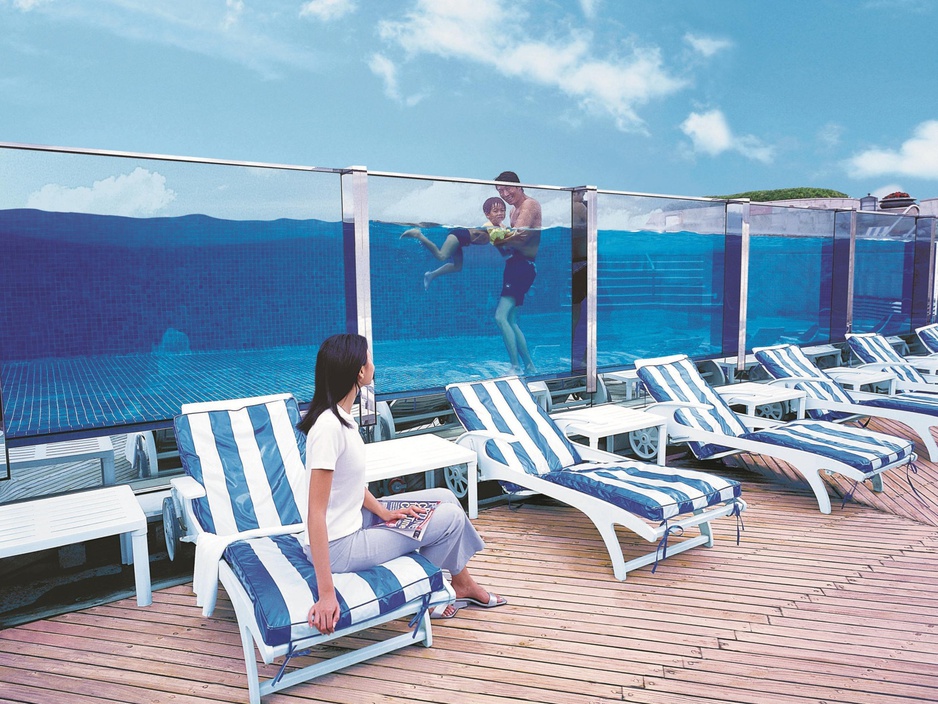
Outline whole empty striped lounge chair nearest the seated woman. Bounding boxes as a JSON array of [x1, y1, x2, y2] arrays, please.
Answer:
[[446, 377, 746, 580]]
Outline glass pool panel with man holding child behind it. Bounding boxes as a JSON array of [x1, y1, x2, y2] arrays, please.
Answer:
[[368, 174, 571, 394]]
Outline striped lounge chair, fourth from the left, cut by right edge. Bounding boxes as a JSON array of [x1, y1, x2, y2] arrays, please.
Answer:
[[753, 345, 938, 462]]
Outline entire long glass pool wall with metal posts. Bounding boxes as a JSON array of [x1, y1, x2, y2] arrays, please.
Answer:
[[0, 145, 936, 496]]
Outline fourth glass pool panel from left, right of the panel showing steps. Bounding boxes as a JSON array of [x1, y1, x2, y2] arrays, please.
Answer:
[[746, 205, 834, 350]]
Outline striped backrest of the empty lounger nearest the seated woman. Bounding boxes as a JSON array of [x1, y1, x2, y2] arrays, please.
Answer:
[[446, 377, 581, 474]]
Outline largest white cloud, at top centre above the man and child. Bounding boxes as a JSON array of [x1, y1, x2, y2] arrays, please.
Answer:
[[379, 0, 686, 130]]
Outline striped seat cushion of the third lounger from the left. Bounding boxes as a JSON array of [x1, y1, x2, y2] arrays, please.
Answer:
[[744, 420, 912, 474]]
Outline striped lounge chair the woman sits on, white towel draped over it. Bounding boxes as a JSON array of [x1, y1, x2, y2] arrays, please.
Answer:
[[169, 396, 455, 704]]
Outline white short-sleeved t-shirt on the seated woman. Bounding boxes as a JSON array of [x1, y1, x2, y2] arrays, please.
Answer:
[[306, 408, 365, 542]]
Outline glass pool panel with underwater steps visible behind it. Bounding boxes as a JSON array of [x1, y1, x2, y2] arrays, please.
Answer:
[[596, 192, 726, 370]]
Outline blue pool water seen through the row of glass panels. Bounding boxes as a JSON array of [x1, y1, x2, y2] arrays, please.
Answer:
[[0, 204, 911, 439]]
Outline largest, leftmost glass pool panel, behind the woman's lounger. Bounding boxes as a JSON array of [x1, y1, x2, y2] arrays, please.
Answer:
[[0, 150, 345, 446]]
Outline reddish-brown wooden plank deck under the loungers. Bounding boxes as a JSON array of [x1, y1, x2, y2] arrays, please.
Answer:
[[0, 454, 938, 704]]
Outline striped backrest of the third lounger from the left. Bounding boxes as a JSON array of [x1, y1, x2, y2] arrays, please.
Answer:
[[635, 355, 748, 437]]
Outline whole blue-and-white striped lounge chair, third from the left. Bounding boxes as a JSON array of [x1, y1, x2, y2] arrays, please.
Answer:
[[635, 355, 916, 513]]
